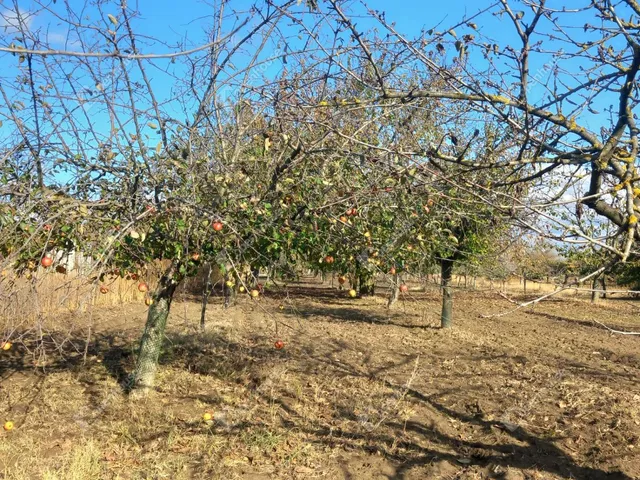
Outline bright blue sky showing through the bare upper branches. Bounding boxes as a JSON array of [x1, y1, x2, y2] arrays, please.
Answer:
[[0, 0, 624, 175]]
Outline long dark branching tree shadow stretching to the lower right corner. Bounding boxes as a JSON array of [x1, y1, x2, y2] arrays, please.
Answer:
[[149, 322, 631, 480]]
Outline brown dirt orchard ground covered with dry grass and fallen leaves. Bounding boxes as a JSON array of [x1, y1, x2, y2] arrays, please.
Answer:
[[0, 280, 640, 480]]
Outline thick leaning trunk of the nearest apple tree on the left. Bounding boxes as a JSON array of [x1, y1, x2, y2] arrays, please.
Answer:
[[132, 264, 178, 396]]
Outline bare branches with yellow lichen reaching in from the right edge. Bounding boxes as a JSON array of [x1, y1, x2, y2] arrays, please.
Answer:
[[360, 0, 640, 284]]
